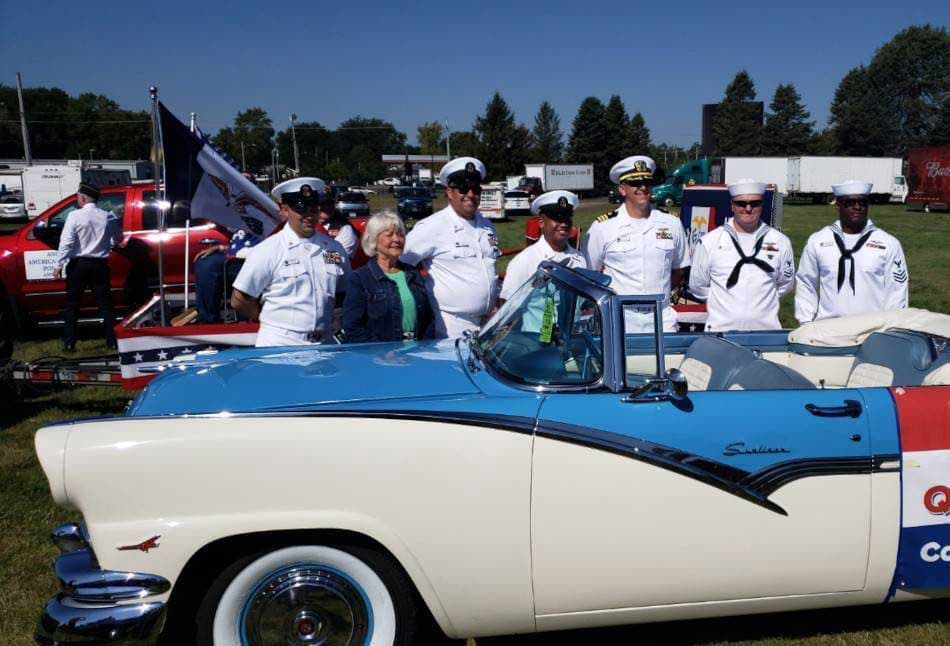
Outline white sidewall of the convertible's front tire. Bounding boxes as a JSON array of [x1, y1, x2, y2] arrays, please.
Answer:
[[213, 545, 396, 646]]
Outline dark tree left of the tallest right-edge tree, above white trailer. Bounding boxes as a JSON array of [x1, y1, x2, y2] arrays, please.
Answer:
[[830, 66, 897, 157]]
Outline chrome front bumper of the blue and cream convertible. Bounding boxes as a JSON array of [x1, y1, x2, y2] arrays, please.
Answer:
[[34, 523, 170, 645]]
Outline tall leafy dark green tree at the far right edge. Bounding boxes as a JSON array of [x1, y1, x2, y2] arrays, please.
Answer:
[[868, 25, 950, 156]]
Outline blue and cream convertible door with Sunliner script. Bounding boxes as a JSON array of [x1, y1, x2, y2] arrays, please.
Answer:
[[531, 304, 871, 616]]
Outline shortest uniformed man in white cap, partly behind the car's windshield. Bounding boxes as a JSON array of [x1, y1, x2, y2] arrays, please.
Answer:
[[501, 191, 587, 302]]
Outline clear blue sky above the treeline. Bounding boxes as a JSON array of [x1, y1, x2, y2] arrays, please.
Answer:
[[0, 0, 950, 146]]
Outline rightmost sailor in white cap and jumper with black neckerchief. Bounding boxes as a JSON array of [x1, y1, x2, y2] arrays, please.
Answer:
[[795, 181, 908, 323]]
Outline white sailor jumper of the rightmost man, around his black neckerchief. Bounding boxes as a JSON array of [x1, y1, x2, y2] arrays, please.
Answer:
[[795, 220, 908, 323]]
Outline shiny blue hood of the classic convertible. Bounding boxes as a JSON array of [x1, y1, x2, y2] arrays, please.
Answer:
[[126, 339, 479, 417]]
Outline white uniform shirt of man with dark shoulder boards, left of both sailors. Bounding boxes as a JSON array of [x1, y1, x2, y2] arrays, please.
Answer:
[[583, 204, 689, 332]]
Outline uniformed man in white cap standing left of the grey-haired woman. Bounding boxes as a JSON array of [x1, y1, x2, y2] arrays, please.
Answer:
[[231, 177, 350, 347]]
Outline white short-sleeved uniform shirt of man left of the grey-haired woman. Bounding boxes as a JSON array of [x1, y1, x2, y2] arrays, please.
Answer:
[[234, 226, 350, 341]]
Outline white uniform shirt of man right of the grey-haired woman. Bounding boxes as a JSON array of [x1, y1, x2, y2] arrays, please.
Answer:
[[402, 205, 501, 320]]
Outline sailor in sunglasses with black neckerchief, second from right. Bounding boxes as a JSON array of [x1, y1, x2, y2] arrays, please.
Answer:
[[689, 179, 795, 332]]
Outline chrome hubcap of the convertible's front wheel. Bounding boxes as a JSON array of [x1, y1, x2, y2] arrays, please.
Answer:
[[241, 565, 371, 646]]
